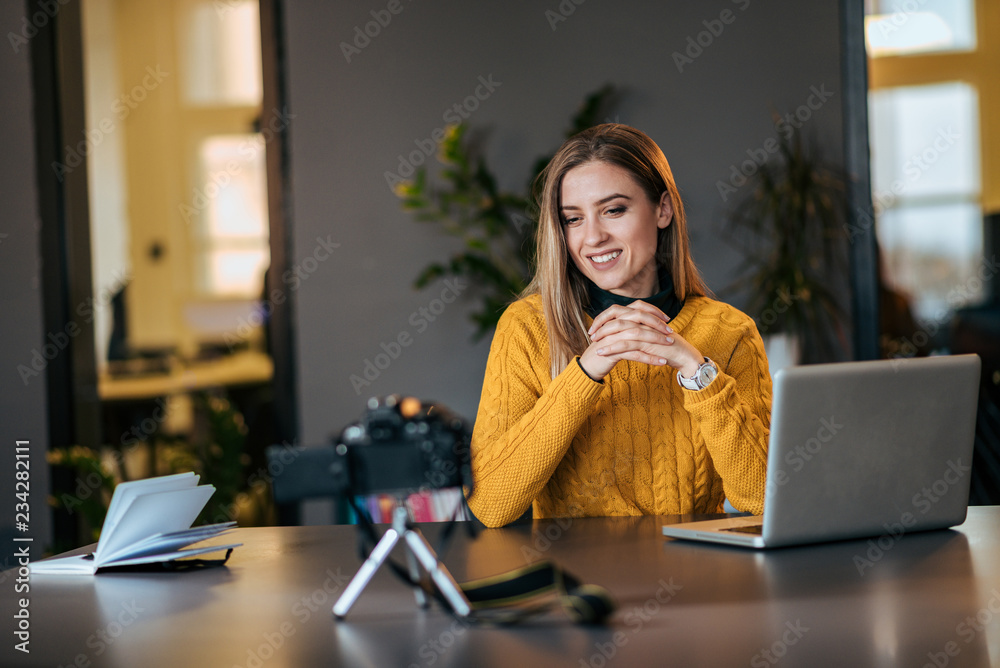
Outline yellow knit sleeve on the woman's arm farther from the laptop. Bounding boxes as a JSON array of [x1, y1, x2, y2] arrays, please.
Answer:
[[469, 302, 604, 527]]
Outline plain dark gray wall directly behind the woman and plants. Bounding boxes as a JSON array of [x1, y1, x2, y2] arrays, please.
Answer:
[[285, 0, 842, 443]]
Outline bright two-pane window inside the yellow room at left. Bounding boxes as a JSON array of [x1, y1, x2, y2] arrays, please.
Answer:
[[180, 0, 269, 299]]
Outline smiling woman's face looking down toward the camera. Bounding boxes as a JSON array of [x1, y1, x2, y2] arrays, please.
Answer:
[[559, 162, 674, 299]]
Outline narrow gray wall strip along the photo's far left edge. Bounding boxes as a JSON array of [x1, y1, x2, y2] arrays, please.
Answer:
[[0, 2, 50, 560]]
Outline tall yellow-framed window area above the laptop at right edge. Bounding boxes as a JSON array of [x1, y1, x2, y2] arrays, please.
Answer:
[[866, 0, 1000, 356]]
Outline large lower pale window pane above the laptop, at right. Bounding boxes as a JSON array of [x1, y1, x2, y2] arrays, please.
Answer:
[[869, 82, 983, 322]]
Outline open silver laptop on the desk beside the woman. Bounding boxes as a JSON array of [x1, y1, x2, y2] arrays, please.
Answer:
[[663, 355, 980, 548]]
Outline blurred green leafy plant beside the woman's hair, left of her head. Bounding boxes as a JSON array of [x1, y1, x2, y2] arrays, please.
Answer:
[[396, 85, 616, 339]]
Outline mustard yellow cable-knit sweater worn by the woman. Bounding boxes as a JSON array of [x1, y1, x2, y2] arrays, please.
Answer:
[[469, 295, 771, 526]]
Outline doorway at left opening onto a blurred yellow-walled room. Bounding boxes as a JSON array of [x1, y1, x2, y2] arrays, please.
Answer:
[[45, 0, 295, 540]]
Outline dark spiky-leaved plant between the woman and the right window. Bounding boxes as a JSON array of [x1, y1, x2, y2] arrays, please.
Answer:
[[727, 117, 846, 361]]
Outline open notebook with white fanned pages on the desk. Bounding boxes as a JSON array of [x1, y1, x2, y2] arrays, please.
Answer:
[[29, 473, 241, 575]]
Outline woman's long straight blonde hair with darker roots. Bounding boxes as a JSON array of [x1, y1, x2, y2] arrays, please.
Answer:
[[521, 123, 707, 378]]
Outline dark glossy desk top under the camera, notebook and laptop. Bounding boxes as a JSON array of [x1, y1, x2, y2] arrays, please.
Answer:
[[7, 507, 1000, 668]]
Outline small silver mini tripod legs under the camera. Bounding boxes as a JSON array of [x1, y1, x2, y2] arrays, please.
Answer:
[[333, 503, 472, 619]]
